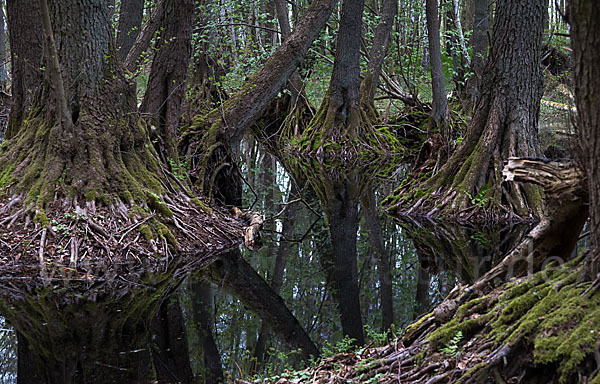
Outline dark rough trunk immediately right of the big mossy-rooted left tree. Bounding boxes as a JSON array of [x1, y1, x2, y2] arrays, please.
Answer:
[[140, 0, 194, 162]]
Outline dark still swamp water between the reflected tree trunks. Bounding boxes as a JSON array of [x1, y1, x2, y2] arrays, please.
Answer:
[[0, 216, 526, 383]]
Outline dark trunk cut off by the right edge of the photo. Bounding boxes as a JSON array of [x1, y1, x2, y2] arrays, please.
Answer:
[[569, 0, 600, 278]]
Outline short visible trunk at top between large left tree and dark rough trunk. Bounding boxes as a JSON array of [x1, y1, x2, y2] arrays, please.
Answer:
[[117, 0, 144, 61]]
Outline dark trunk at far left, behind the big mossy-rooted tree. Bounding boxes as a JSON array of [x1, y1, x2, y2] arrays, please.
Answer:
[[5, 0, 44, 139]]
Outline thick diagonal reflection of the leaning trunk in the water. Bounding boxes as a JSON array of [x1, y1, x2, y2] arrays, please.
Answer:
[[208, 250, 319, 361]]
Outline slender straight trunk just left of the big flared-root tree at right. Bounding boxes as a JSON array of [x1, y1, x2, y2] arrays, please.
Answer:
[[425, 0, 448, 137]]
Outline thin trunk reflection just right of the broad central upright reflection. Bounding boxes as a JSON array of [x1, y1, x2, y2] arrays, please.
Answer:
[[361, 187, 394, 331]]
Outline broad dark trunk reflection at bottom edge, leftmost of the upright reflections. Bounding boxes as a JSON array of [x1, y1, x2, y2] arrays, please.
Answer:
[[150, 298, 194, 383]]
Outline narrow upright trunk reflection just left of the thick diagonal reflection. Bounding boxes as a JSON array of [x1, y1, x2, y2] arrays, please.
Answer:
[[190, 276, 223, 384]]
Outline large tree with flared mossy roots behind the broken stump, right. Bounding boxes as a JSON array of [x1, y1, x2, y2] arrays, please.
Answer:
[[388, 0, 546, 220]]
